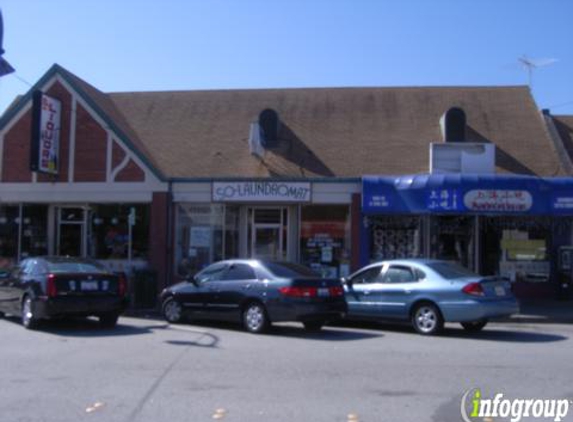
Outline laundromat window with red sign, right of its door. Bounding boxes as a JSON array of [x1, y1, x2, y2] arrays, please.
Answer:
[[300, 205, 351, 278]]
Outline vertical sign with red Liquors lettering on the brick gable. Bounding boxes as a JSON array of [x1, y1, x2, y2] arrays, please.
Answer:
[[30, 91, 62, 174]]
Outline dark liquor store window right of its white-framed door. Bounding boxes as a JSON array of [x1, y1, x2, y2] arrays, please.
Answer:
[[88, 204, 149, 260]]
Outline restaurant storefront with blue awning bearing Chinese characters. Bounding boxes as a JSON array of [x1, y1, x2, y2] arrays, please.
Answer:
[[361, 174, 573, 297]]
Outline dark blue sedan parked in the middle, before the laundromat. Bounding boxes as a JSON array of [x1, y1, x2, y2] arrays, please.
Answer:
[[160, 259, 346, 333]]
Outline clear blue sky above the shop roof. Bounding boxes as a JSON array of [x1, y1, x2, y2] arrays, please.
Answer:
[[0, 0, 573, 114]]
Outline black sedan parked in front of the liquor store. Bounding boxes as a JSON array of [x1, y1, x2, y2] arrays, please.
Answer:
[[0, 256, 127, 328]]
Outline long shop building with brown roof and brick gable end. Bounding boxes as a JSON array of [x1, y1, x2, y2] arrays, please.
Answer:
[[0, 65, 573, 302]]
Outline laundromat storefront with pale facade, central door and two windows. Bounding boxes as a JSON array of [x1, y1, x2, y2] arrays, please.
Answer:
[[173, 180, 359, 277]]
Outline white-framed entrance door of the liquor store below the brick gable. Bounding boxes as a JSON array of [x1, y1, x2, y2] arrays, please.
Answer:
[[55, 207, 88, 256]]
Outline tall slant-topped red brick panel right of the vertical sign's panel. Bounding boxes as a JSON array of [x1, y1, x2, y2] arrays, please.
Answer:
[[74, 104, 107, 182]]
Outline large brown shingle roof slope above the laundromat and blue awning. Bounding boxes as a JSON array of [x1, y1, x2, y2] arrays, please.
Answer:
[[108, 87, 563, 178]]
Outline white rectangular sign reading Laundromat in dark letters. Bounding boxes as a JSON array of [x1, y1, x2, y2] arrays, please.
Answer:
[[213, 182, 311, 202]]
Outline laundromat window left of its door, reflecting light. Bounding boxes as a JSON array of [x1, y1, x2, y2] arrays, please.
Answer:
[[175, 204, 239, 276]]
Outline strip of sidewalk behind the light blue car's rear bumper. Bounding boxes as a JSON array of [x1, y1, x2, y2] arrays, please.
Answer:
[[509, 299, 573, 324]]
